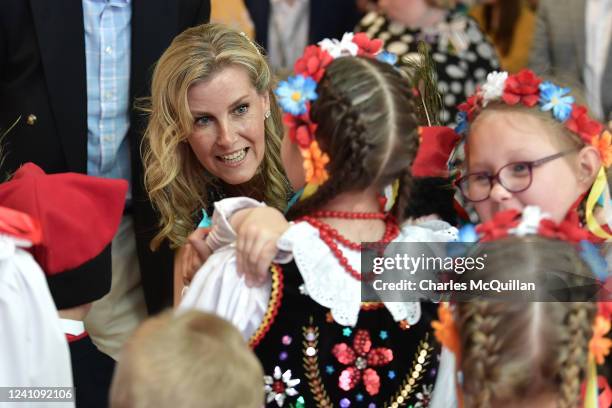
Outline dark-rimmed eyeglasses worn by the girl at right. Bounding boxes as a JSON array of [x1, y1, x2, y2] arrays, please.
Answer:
[[455, 149, 576, 202]]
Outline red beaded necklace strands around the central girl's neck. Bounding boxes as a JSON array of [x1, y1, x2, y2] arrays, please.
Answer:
[[298, 211, 399, 281]]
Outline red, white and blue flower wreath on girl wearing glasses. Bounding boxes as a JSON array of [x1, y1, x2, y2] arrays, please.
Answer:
[[455, 69, 612, 239]]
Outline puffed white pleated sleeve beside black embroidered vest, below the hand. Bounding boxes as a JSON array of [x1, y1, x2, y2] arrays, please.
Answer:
[[178, 245, 272, 340]]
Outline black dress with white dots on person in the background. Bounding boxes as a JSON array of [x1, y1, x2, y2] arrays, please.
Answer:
[[355, 12, 499, 126]]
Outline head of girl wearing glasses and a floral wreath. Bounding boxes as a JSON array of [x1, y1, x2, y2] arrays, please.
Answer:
[[456, 70, 612, 238]]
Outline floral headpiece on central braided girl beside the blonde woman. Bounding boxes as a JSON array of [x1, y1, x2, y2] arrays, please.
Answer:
[[276, 33, 397, 198]]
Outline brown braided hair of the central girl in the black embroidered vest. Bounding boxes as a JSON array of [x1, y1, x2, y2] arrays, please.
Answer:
[[288, 57, 419, 222]]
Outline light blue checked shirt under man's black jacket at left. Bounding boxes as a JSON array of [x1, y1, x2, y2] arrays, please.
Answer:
[[82, 0, 132, 202]]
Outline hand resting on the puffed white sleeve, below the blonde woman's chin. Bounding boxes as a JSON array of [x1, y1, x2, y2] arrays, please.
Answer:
[[231, 207, 289, 287]]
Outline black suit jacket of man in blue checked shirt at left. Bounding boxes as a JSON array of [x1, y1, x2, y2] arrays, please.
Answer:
[[0, 0, 210, 313]]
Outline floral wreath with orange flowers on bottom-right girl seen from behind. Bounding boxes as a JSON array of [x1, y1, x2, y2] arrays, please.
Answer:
[[432, 206, 612, 408]]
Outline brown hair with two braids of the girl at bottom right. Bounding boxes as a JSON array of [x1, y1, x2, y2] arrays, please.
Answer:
[[455, 236, 597, 408]]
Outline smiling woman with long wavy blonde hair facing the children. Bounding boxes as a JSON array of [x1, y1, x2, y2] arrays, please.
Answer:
[[143, 24, 289, 302]]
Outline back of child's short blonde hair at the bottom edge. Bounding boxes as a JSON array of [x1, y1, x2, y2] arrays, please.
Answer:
[[111, 311, 264, 408]]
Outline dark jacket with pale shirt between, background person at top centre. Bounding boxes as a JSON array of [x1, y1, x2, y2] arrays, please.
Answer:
[[244, 0, 361, 48]]
